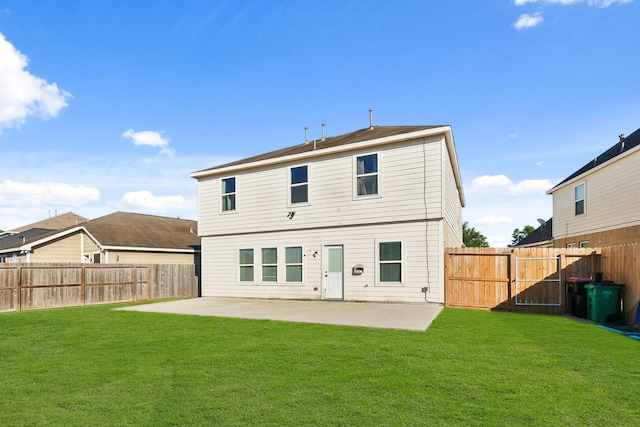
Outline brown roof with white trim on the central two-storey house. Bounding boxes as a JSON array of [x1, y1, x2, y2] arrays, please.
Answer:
[[191, 125, 465, 206]]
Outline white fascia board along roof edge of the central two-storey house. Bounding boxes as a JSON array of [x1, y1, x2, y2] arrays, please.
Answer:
[[189, 126, 456, 181]]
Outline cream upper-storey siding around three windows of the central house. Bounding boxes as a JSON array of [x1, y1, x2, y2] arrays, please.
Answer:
[[198, 138, 444, 236]]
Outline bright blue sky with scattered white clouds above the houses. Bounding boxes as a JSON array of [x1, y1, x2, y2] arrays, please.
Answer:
[[0, 0, 640, 246]]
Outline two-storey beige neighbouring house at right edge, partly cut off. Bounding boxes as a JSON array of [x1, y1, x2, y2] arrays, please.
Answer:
[[547, 129, 640, 248]]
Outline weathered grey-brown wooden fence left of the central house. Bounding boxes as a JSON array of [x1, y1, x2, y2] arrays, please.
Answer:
[[0, 264, 198, 311]]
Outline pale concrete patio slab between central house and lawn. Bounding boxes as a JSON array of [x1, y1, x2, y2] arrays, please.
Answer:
[[116, 297, 442, 331]]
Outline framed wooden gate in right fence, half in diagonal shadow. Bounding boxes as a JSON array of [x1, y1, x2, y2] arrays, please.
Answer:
[[514, 256, 564, 307]]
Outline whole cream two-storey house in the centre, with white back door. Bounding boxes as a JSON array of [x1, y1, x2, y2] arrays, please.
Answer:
[[191, 126, 464, 302]]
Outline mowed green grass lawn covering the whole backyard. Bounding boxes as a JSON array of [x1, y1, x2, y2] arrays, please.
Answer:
[[0, 306, 640, 426]]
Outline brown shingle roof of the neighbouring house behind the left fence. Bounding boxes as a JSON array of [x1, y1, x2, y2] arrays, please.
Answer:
[[83, 212, 200, 250]]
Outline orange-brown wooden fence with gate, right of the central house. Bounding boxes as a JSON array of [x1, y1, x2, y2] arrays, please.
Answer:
[[445, 248, 601, 314]]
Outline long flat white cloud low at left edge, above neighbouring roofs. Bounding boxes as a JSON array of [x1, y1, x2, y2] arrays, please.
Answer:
[[0, 179, 100, 207]]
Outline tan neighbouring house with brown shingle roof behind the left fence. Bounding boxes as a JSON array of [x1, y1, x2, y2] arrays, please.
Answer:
[[0, 212, 200, 264]]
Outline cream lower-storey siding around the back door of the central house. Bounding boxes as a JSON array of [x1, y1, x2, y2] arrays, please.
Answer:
[[202, 221, 444, 302]]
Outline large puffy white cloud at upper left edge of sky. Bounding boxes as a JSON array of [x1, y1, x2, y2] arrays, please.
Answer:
[[0, 33, 72, 134]]
